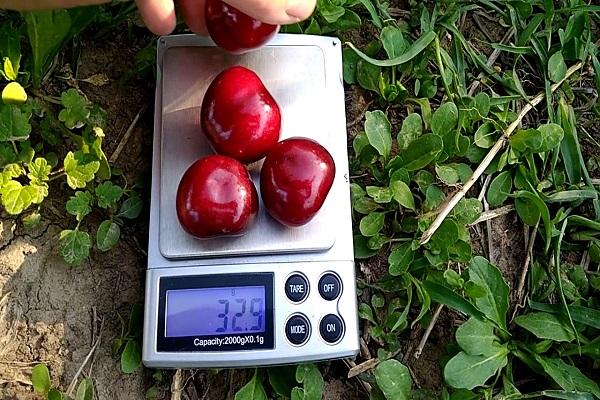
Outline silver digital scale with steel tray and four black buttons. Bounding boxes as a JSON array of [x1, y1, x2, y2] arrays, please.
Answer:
[[142, 34, 359, 368]]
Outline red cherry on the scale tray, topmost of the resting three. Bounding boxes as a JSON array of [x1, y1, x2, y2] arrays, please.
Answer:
[[200, 66, 281, 164]]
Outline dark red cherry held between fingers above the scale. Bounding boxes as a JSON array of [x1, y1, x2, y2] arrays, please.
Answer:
[[205, 0, 279, 54]]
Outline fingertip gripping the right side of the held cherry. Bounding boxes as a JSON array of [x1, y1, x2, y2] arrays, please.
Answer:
[[225, 0, 317, 25]]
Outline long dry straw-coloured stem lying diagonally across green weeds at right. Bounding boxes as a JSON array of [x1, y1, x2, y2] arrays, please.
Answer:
[[420, 62, 583, 244]]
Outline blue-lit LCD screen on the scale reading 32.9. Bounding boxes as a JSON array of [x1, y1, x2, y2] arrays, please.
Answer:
[[165, 286, 266, 337]]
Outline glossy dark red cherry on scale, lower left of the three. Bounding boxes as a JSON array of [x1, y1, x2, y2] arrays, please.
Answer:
[[176, 155, 258, 239]]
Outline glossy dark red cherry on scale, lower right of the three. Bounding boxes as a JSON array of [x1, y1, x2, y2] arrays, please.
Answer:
[[260, 138, 335, 227]]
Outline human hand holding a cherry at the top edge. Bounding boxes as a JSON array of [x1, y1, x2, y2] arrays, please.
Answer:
[[0, 0, 316, 35]]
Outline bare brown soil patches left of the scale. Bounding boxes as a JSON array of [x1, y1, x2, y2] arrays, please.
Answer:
[[0, 26, 153, 400]]
